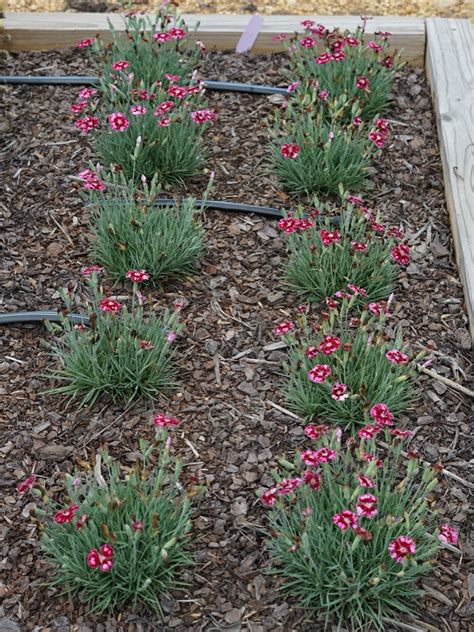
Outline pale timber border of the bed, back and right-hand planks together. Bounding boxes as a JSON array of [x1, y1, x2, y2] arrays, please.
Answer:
[[0, 13, 474, 340]]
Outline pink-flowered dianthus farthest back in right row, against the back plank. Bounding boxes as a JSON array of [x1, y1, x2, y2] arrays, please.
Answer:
[[286, 20, 401, 121]]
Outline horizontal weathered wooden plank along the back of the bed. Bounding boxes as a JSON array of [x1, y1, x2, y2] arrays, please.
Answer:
[[0, 13, 425, 66]]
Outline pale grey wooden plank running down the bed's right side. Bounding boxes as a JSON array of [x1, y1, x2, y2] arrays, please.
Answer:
[[426, 18, 474, 341]]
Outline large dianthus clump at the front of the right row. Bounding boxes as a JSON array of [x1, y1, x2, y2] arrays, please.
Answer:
[[260, 426, 457, 632]]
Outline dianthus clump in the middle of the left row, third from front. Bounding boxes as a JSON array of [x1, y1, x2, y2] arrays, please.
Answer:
[[85, 172, 204, 285]]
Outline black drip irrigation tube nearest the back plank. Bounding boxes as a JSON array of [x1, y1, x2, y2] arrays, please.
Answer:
[[0, 75, 288, 94]]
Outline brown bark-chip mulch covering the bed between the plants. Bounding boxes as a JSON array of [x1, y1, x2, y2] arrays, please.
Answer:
[[0, 51, 474, 632]]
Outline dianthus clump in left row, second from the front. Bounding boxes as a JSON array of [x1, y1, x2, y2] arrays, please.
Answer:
[[47, 272, 180, 405]]
